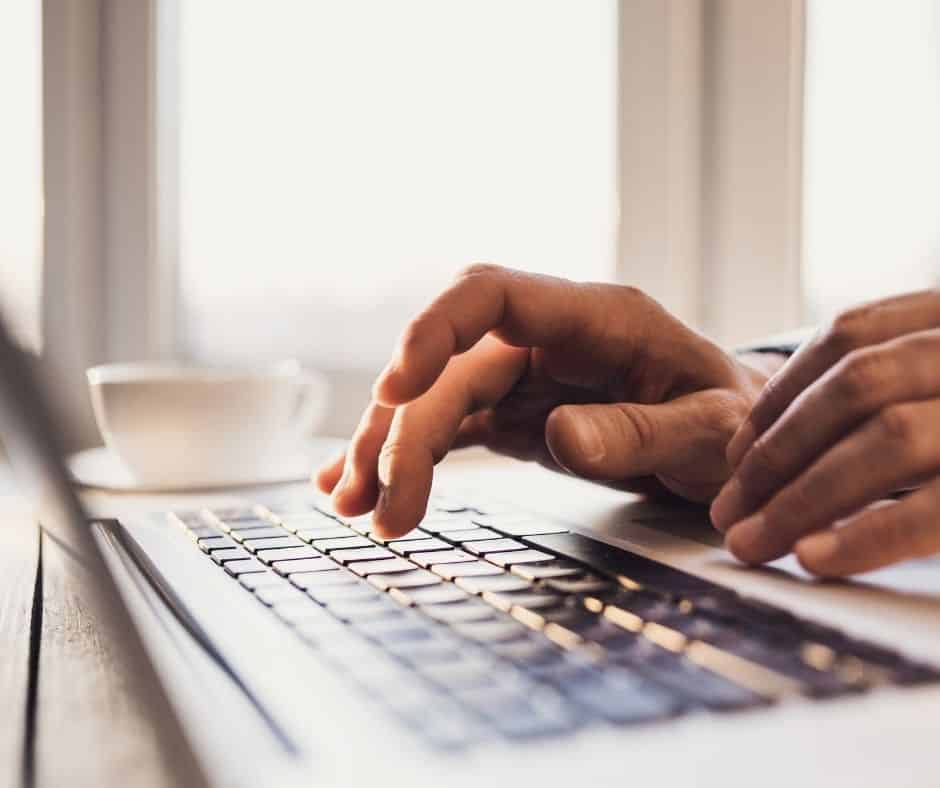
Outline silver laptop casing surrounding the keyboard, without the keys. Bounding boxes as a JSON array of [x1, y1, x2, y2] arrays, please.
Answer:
[[0, 316, 940, 788]]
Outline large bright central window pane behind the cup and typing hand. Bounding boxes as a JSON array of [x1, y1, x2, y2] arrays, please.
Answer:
[[179, 0, 617, 376]]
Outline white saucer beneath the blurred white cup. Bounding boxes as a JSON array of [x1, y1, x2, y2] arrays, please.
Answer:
[[67, 438, 346, 493]]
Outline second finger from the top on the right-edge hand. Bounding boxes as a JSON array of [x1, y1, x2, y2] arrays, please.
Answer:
[[711, 329, 940, 531]]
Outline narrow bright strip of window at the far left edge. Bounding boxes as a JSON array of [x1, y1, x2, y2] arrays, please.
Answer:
[[0, 0, 43, 347]]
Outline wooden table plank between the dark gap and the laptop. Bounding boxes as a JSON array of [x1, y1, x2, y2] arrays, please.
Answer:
[[33, 535, 204, 788]]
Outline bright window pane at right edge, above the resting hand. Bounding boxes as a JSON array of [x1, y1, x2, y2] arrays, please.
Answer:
[[803, 0, 940, 321]]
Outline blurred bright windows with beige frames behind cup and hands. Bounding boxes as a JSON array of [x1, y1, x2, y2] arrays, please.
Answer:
[[0, 0, 940, 445]]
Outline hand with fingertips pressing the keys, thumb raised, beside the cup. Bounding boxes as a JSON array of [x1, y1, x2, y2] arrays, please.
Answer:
[[317, 265, 770, 537]]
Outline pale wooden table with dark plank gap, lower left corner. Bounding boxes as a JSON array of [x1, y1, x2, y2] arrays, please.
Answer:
[[0, 471, 202, 788]]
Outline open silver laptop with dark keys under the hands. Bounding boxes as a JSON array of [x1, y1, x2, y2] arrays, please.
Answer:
[[0, 316, 940, 788]]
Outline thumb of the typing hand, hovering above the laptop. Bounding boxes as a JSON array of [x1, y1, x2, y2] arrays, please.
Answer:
[[545, 389, 746, 481]]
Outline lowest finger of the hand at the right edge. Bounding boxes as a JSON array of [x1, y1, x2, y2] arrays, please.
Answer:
[[796, 481, 940, 577]]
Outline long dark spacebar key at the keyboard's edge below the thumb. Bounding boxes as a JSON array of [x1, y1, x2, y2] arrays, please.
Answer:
[[520, 533, 729, 595]]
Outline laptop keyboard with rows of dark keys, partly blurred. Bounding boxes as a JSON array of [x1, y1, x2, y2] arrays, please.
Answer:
[[170, 497, 940, 748]]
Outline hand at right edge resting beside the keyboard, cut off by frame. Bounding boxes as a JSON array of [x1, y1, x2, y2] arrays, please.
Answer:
[[711, 290, 940, 576]]
